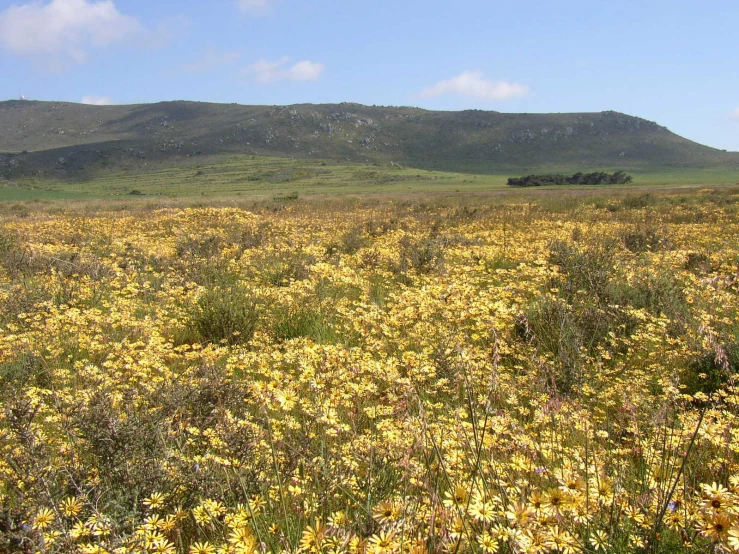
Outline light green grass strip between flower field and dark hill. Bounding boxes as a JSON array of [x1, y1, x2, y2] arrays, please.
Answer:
[[0, 155, 739, 202]]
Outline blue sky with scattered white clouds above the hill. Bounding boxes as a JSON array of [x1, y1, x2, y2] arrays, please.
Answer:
[[0, 0, 739, 151]]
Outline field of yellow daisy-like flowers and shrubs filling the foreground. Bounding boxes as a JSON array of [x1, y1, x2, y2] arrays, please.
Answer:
[[0, 189, 739, 554]]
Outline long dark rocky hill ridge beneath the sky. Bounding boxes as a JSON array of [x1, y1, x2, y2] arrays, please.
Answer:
[[0, 101, 739, 179]]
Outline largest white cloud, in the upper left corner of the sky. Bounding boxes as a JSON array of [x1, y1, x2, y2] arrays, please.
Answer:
[[0, 0, 142, 69]]
